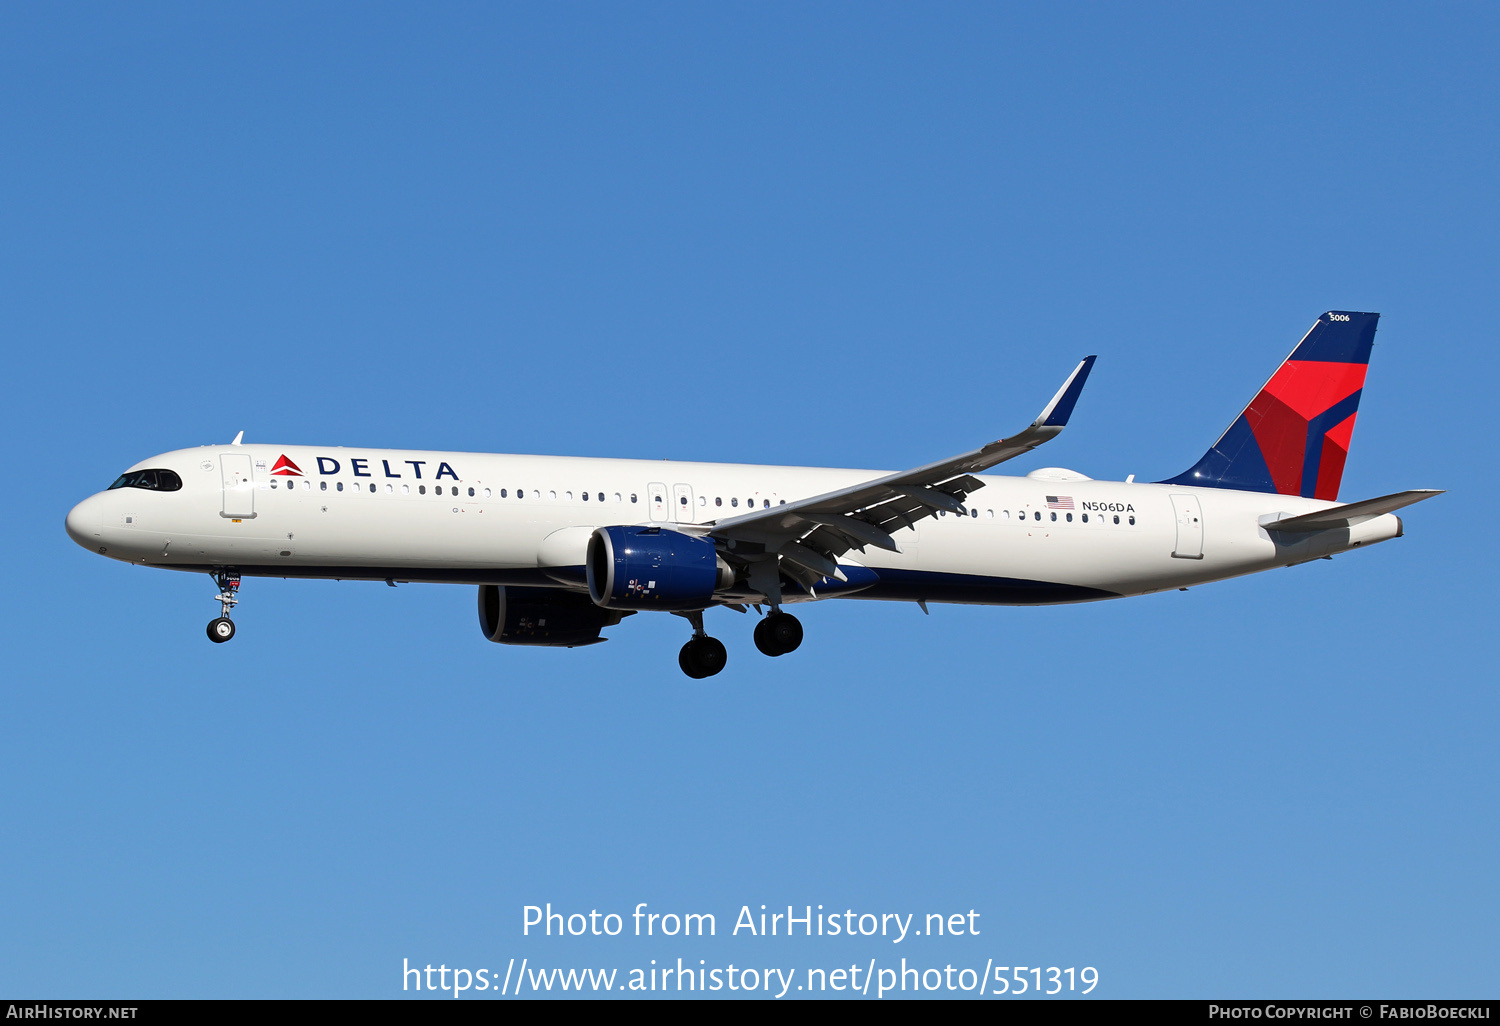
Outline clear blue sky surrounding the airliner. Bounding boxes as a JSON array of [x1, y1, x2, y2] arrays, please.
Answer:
[[0, 5, 1500, 998]]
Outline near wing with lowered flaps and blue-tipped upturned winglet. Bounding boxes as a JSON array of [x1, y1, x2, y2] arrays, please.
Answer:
[[707, 356, 1094, 602]]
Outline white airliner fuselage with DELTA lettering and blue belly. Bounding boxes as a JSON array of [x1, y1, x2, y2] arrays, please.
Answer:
[[68, 446, 1401, 605]]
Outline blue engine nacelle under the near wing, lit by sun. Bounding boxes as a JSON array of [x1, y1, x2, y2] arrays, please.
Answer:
[[588, 527, 735, 609]]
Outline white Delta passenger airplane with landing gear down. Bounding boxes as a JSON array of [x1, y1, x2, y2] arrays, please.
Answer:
[[66, 311, 1442, 680]]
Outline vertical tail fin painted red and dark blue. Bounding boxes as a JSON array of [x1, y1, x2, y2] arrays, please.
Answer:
[[1163, 311, 1380, 500]]
